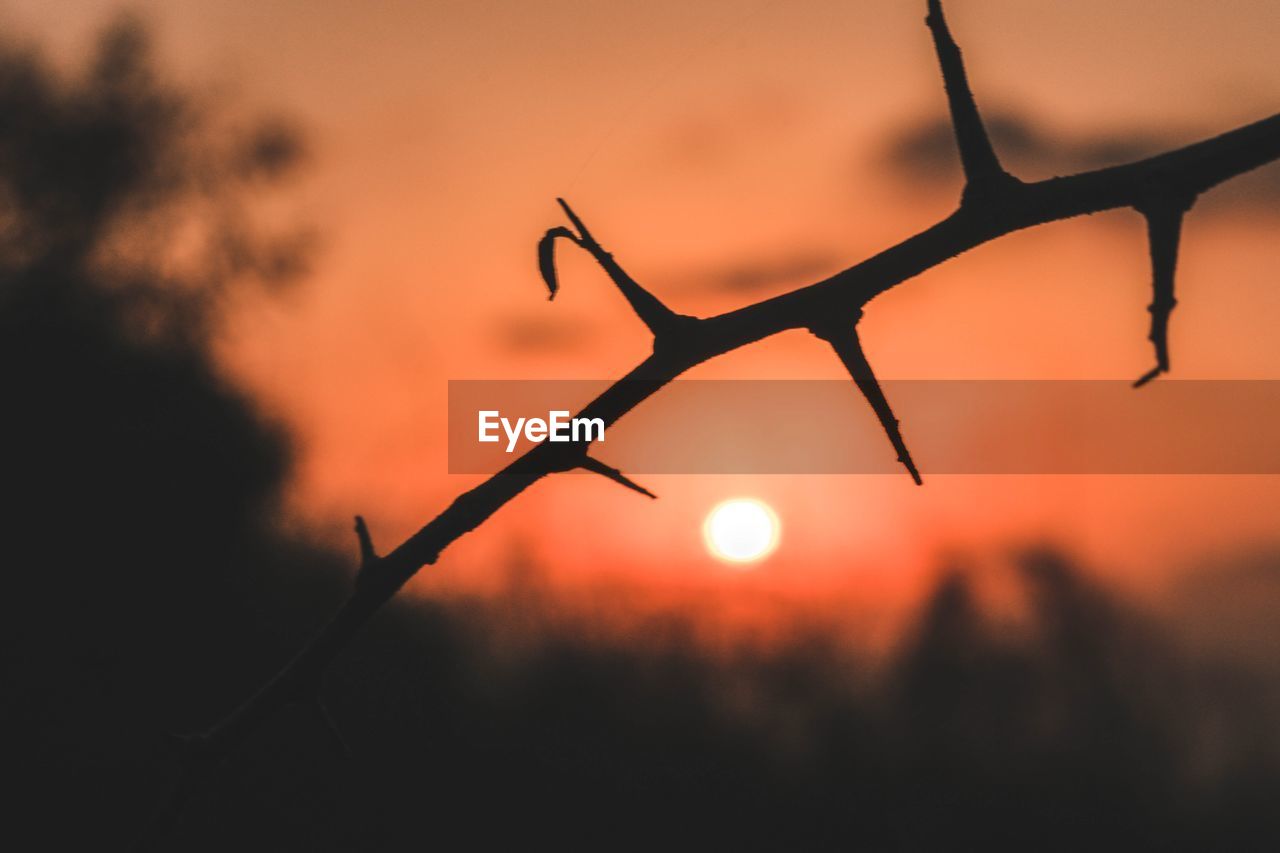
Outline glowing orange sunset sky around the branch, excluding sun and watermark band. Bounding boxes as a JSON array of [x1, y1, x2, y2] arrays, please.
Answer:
[[0, 0, 1280, 614]]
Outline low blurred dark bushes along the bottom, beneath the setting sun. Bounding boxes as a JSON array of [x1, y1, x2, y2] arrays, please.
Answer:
[[127, 551, 1280, 850]]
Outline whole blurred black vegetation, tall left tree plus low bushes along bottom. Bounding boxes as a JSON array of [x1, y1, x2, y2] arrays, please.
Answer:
[[0, 13, 1280, 852]]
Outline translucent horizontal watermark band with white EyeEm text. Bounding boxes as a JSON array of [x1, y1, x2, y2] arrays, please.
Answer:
[[448, 379, 1280, 479]]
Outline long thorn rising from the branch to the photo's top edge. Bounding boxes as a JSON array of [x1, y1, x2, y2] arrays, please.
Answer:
[[924, 0, 1015, 200]]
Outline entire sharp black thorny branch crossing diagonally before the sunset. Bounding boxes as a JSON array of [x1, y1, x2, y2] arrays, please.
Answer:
[[140, 0, 1280, 847]]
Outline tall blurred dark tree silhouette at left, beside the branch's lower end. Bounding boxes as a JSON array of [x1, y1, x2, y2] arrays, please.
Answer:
[[0, 19, 337, 838]]
